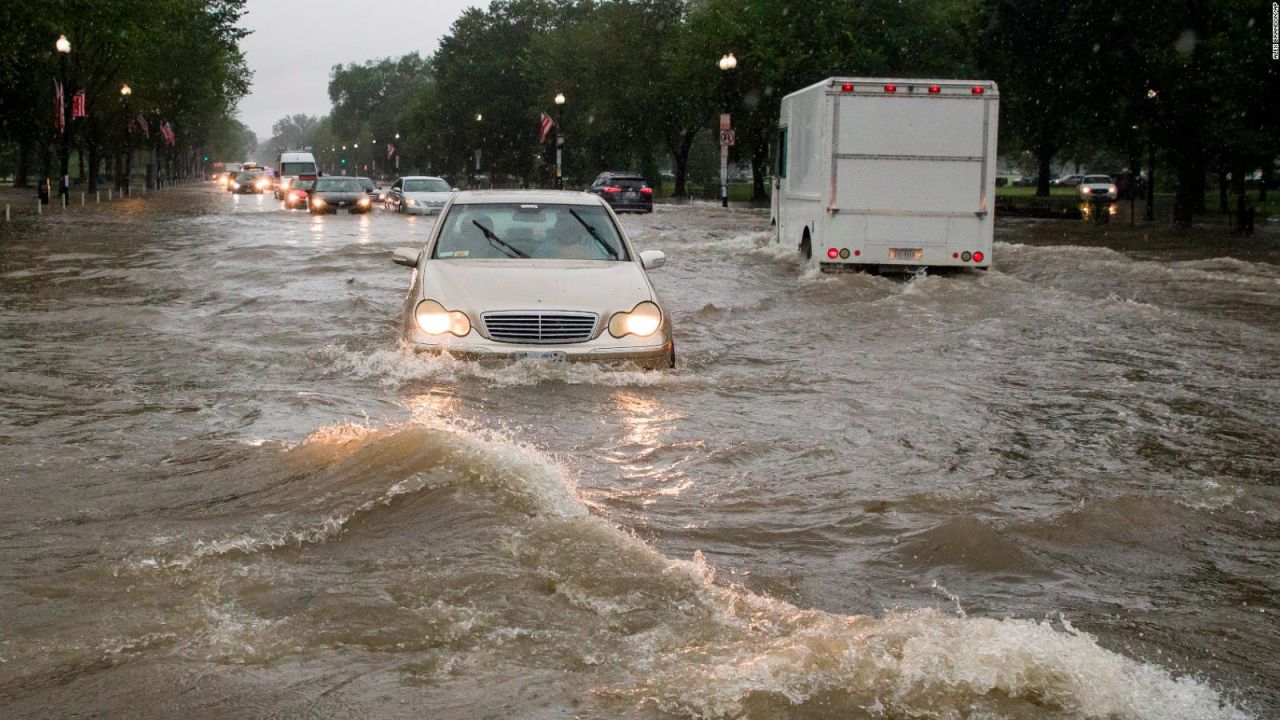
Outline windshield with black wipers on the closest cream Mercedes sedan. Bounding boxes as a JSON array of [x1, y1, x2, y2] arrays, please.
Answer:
[[431, 202, 631, 260]]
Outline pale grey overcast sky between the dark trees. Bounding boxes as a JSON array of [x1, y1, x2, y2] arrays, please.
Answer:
[[239, 0, 488, 141]]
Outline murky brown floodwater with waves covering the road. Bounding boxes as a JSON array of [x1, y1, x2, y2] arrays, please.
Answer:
[[0, 184, 1280, 719]]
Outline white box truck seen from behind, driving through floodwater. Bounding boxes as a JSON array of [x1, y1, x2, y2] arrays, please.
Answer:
[[773, 78, 1000, 272]]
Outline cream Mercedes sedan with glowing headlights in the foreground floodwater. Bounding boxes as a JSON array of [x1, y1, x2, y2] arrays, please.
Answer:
[[393, 190, 676, 369]]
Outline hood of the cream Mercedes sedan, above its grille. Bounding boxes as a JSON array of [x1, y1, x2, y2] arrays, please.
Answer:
[[421, 254, 654, 320]]
